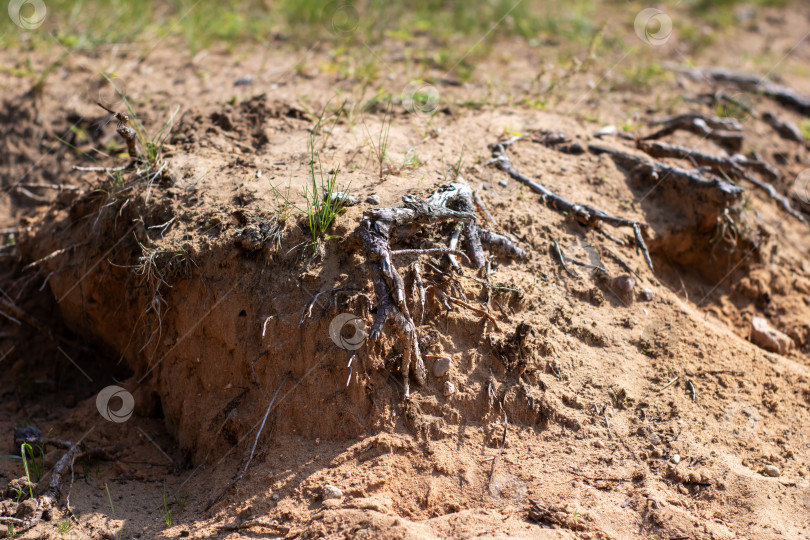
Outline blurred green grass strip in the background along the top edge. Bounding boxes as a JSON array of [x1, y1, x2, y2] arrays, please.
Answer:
[[0, 0, 799, 88]]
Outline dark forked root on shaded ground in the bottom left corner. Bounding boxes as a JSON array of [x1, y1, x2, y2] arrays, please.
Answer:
[[0, 426, 109, 534]]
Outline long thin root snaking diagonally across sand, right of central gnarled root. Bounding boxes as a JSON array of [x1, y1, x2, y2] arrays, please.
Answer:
[[487, 137, 653, 270]]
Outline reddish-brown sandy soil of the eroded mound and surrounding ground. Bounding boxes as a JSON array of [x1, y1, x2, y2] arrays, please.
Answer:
[[0, 5, 810, 539]]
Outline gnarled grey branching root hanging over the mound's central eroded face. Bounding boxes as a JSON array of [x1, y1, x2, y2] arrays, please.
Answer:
[[352, 182, 526, 397]]
